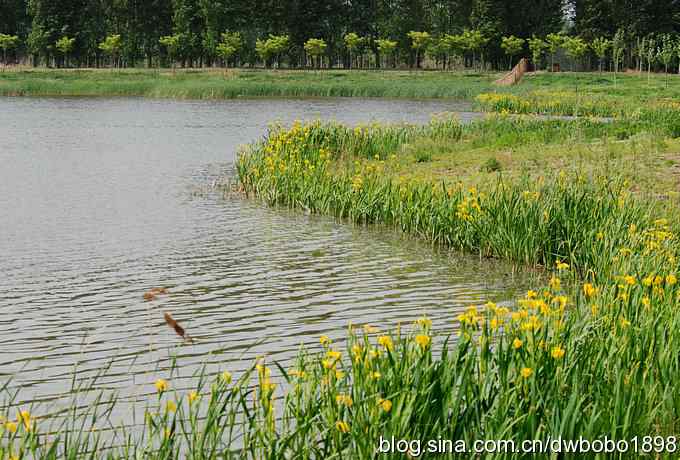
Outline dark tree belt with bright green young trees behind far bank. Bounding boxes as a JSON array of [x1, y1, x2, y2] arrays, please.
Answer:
[[0, 0, 680, 71]]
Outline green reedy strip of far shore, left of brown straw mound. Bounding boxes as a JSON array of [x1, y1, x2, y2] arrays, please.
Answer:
[[0, 70, 495, 100]]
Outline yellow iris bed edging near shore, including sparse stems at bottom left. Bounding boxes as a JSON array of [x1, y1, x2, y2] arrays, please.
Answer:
[[0, 116, 680, 459]]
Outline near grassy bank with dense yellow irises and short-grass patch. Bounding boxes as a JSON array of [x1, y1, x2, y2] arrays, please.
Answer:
[[231, 116, 680, 458]]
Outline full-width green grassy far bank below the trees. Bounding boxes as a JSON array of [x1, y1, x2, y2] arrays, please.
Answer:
[[0, 68, 680, 103]]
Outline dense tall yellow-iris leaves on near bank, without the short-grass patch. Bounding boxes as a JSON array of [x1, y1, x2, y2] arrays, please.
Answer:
[[231, 119, 680, 458]]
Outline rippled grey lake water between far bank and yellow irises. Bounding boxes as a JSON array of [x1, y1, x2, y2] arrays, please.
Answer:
[[0, 98, 521, 420]]
